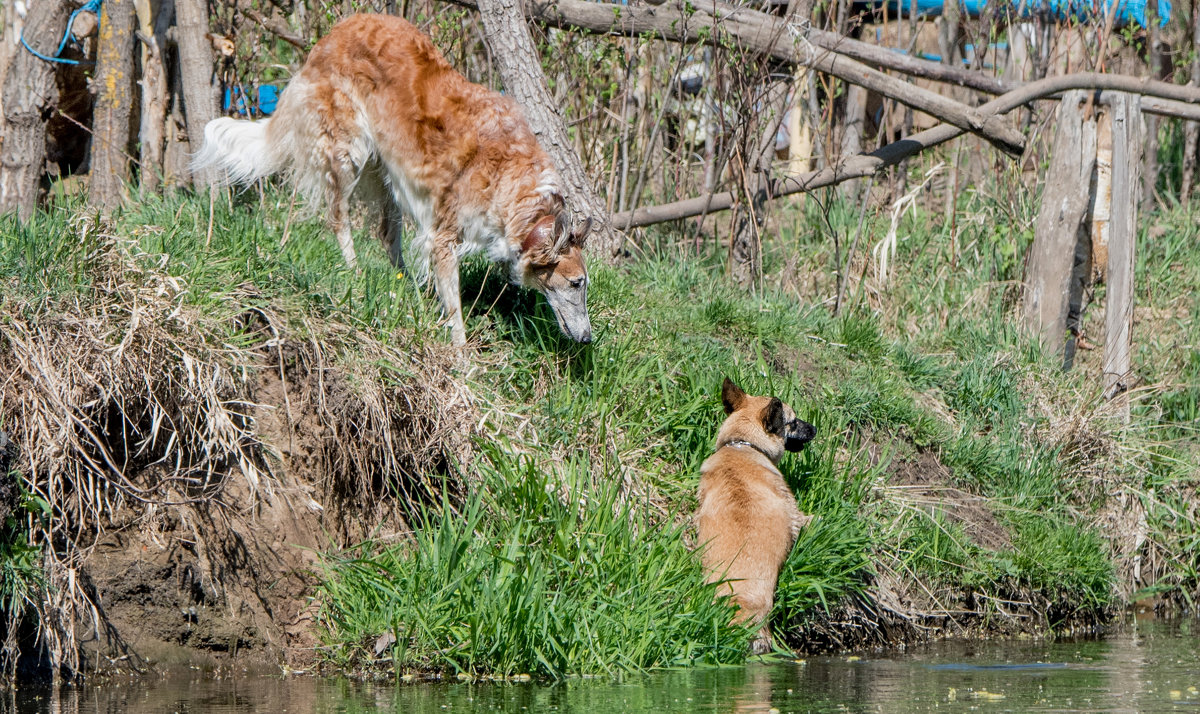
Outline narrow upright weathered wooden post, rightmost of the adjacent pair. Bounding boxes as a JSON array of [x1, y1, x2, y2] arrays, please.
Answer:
[[1103, 92, 1146, 420]]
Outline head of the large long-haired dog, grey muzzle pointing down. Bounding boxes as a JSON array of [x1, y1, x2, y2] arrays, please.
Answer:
[[521, 212, 592, 342]]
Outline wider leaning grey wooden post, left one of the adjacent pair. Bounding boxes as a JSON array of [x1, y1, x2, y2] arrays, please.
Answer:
[[1025, 90, 1096, 354]]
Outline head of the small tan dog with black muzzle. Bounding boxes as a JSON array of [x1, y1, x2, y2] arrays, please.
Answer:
[[716, 377, 817, 461]]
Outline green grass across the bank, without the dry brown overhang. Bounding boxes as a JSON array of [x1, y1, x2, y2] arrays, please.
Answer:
[[0, 176, 1200, 676]]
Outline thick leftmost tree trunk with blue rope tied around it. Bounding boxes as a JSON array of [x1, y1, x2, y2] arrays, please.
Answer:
[[0, 0, 71, 221]]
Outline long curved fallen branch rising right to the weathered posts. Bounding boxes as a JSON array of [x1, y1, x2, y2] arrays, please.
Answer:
[[612, 72, 1200, 230]]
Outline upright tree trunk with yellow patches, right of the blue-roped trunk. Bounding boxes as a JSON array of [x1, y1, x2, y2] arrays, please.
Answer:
[[88, 0, 134, 210]]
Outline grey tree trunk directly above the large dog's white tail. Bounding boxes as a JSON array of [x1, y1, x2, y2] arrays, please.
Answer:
[[175, 0, 218, 188]]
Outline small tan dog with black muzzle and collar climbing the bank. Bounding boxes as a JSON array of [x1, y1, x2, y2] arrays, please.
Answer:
[[696, 378, 816, 654]]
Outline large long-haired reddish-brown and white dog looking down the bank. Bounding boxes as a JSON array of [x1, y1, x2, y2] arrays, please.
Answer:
[[194, 14, 592, 344]]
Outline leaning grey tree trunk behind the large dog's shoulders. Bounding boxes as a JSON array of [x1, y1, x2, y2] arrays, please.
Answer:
[[479, 0, 624, 259]]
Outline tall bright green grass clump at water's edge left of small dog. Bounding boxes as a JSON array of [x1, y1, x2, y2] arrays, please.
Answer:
[[322, 444, 750, 677]]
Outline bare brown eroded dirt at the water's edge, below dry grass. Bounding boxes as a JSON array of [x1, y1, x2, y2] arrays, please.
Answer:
[[78, 371, 345, 670]]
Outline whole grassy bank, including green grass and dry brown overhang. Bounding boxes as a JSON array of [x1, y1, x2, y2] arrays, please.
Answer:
[[0, 180, 1200, 676]]
